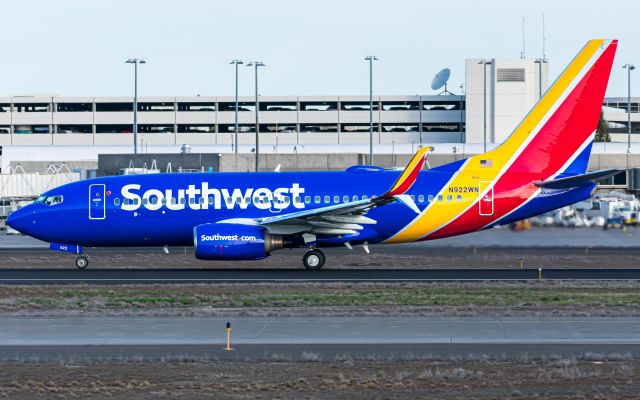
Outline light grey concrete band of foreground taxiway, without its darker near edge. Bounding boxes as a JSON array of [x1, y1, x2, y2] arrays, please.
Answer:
[[0, 317, 640, 346]]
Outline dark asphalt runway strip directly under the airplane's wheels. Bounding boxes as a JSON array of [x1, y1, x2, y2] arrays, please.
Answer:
[[0, 268, 640, 285]]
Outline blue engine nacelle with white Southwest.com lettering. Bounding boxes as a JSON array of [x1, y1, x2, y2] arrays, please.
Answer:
[[193, 224, 283, 260]]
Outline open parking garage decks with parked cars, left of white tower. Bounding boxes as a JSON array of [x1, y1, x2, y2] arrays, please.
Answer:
[[0, 96, 464, 149]]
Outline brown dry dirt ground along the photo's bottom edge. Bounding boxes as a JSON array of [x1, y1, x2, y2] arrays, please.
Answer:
[[0, 359, 640, 400]]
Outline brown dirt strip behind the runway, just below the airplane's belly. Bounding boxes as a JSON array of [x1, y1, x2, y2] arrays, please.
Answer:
[[0, 245, 640, 269]]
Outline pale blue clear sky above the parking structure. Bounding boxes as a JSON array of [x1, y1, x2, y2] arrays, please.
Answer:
[[0, 0, 640, 96]]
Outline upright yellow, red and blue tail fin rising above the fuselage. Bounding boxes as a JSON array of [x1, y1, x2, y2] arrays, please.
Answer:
[[488, 39, 618, 179]]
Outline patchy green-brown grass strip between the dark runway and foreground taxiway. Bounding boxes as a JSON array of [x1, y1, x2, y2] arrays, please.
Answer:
[[0, 282, 640, 315]]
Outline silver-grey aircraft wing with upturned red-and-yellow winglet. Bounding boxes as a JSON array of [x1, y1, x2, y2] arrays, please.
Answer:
[[220, 146, 433, 239]]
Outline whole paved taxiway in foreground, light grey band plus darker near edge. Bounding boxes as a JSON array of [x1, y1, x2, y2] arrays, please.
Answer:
[[0, 317, 640, 362]]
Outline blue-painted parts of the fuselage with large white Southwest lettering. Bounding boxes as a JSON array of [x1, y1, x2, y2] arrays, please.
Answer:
[[11, 161, 591, 247]]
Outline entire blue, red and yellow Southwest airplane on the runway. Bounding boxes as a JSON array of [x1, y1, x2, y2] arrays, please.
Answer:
[[7, 40, 619, 270]]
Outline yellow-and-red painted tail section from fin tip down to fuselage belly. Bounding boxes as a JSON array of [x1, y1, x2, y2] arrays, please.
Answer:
[[387, 40, 618, 242]]
